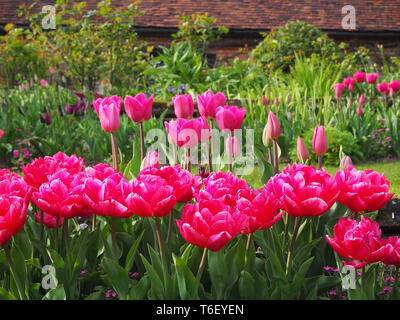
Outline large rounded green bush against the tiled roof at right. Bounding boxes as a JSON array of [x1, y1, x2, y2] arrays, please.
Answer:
[[250, 21, 342, 72]]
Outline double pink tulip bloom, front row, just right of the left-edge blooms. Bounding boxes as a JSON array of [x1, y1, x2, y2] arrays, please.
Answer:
[[32, 169, 91, 218]]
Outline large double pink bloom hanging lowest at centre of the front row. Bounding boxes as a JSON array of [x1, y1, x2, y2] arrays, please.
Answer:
[[176, 200, 246, 251]]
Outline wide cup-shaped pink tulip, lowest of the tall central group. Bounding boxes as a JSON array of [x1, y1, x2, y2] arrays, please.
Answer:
[[164, 118, 204, 148]]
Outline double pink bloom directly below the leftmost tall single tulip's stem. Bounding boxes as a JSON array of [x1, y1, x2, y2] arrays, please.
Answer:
[[83, 172, 133, 218]]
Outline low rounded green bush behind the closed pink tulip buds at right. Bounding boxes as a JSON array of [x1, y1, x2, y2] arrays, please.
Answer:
[[289, 127, 362, 166]]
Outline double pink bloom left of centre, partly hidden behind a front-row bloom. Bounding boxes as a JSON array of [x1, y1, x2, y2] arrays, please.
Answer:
[[138, 165, 201, 203]]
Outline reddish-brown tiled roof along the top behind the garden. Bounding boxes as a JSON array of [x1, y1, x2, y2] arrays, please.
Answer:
[[0, 0, 400, 31]]
